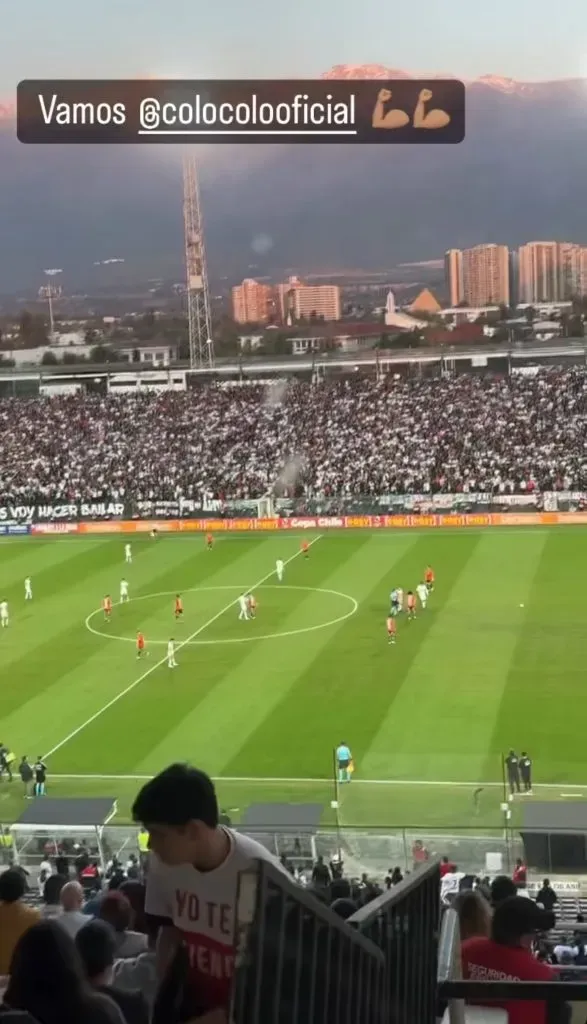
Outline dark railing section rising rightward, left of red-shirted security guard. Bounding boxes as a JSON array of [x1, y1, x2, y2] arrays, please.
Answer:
[[347, 861, 441, 1024]]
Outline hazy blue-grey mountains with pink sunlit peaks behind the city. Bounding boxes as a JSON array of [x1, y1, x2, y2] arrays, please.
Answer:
[[0, 66, 587, 293]]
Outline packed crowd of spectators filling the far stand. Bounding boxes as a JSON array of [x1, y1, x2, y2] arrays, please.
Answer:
[[0, 368, 587, 505]]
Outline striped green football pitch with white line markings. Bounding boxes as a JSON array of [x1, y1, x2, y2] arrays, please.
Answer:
[[0, 527, 587, 831]]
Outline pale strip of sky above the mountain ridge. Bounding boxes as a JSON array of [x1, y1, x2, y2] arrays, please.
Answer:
[[0, 0, 587, 94]]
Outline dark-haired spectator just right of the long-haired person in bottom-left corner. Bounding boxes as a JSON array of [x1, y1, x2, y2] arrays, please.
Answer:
[[76, 921, 149, 1024]]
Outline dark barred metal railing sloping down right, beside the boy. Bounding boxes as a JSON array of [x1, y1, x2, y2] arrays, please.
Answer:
[[232, 861, 389, 1024]]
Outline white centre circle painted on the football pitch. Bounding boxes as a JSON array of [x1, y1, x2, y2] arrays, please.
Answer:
[[84, 584, 359, 647]]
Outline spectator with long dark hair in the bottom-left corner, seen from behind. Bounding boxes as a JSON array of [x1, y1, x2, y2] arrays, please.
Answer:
[[4, 921, 125, 1024]]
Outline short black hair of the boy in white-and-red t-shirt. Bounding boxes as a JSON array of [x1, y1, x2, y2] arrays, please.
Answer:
[[132, 764, 218, 828]]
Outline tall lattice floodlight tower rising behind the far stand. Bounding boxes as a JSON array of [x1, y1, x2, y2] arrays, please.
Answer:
[[183, 154, 214, 368]]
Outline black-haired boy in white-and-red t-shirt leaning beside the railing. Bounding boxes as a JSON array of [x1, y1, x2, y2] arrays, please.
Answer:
[[132, 764, 284, 1017]]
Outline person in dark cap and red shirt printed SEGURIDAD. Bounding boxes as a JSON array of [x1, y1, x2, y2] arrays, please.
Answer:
[[461, 896, 556, 1024]]
